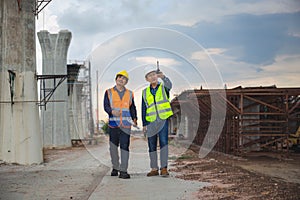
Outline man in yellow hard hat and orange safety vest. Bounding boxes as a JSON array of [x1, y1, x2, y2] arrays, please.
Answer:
[[104, 70, 137, 179]]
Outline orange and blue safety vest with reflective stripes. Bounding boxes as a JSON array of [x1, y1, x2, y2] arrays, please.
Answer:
[[107, 88, 133, 128]]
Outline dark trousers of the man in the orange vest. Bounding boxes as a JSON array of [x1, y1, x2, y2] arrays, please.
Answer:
[[109, 127, 130, 172]]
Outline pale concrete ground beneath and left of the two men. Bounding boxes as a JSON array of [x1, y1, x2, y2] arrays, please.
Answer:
[[0, 137, 208, 200]]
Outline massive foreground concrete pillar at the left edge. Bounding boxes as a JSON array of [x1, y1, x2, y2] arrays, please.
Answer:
[[0, 0, 43, 164]]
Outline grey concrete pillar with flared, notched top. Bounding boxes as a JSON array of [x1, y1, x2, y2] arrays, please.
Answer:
[[38, 30, 72, 148]]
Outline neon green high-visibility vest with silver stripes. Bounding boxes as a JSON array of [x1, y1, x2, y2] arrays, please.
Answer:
[[143, 84, 173, 122]]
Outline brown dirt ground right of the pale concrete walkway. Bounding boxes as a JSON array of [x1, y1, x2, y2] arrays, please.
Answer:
[[171, 147, 300, 200]]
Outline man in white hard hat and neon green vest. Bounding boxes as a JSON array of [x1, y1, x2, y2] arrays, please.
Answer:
[[142, 65, 173, 177]]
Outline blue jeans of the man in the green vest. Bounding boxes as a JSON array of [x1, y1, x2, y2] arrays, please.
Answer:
[[147, 119, 168, 169]]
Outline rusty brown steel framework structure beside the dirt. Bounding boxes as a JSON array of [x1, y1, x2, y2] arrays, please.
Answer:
[[171, 86, 300, 154]]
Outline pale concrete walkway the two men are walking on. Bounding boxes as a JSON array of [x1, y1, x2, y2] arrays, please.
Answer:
[[89, 137, 208, 200]]
